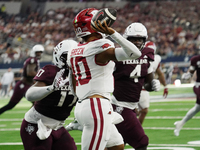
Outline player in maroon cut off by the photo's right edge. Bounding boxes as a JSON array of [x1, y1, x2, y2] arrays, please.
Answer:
[[174, 55, 200, 136]]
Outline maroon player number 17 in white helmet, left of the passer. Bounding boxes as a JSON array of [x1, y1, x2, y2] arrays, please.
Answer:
[[20, 40, 77, 150]]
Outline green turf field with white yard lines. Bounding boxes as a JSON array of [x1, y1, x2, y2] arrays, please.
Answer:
[[0, 85, 200, 150]]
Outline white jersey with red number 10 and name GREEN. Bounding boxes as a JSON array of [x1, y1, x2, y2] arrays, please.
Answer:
[[68, 39, 115, 100]]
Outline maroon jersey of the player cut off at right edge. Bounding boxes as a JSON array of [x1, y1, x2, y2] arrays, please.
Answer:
[[190, 55, 200, 82]]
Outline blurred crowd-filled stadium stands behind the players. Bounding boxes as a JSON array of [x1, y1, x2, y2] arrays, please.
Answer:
[[0, 0, 200, 83]]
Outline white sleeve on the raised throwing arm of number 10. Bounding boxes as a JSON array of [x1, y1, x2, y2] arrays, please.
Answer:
[[110, 31, 141, 61]]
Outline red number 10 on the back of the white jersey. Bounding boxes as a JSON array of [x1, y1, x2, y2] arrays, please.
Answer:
[[70, 56, 91, 86]]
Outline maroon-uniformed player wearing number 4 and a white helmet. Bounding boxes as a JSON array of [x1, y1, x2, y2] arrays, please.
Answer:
[[111, 22, 160, 150]]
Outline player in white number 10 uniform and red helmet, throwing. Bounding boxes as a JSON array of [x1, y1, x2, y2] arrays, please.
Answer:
[[68, 8, 141, 150]]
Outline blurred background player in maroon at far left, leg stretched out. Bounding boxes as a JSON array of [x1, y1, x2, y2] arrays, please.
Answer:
[[0, 44, 44, 114]]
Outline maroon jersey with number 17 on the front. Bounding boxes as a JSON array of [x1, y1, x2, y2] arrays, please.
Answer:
[[34, 65, 76, 120]]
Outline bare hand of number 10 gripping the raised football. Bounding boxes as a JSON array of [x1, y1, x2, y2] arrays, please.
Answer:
[[91, 20, 115, 35]]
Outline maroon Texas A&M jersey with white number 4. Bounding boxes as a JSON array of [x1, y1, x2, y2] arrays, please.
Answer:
[[113, 48, 154, 102]]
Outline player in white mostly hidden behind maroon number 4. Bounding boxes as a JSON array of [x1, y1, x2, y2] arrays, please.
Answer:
[[138, 41, 168, 124]]
